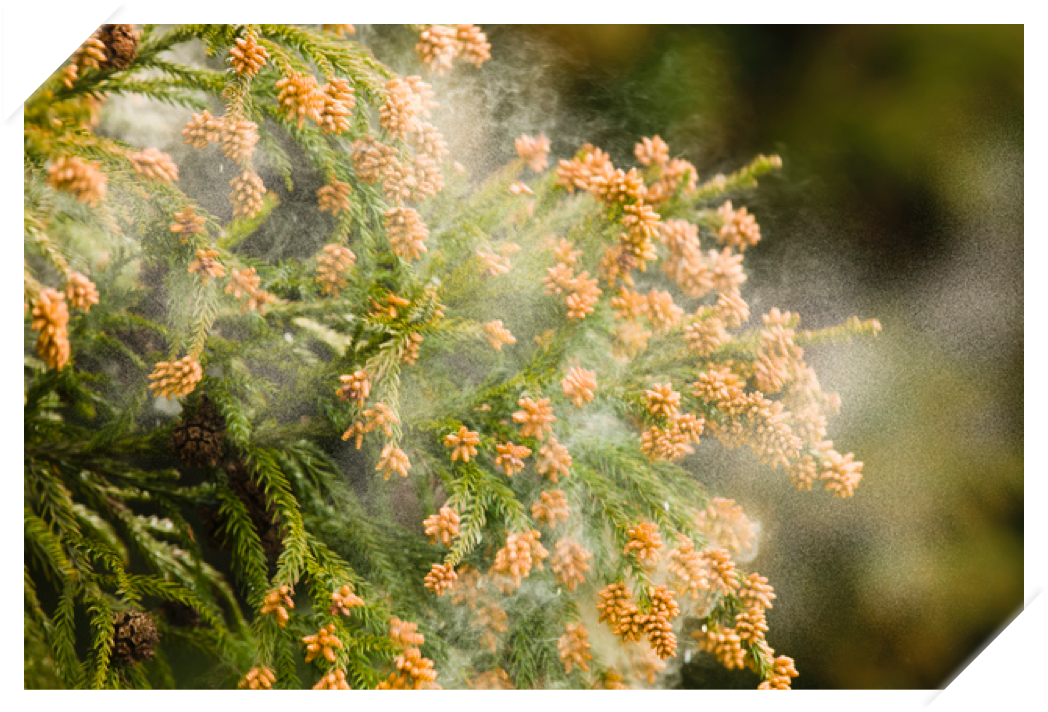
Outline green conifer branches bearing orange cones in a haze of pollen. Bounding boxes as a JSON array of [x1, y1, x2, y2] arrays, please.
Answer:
[[23, 25, 875, 689]]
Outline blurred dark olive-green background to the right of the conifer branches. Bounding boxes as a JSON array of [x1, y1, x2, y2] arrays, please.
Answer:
[[473, 25, 1022, 689]]
